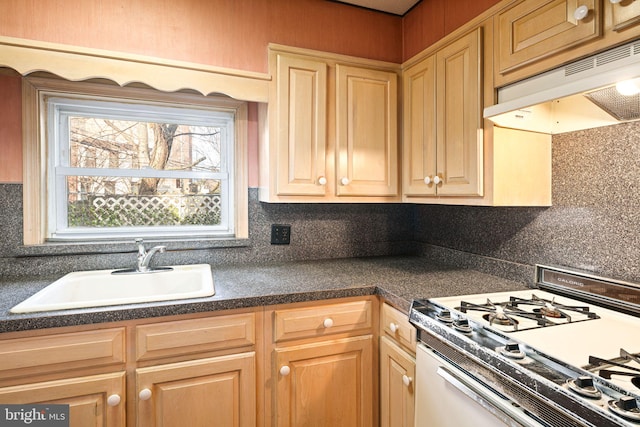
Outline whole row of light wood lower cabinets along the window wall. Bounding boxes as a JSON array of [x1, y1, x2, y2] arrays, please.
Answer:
[[0, 296, 382, 427]]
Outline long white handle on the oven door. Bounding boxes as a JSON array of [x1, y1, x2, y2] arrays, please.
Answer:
[[436, 366, 548, 427]]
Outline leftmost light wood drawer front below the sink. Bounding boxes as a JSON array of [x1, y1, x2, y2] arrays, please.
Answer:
[[0, 328, 125, 378]]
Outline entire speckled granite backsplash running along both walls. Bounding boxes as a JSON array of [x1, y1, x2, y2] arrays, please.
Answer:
[[0, 123, 640, 282]]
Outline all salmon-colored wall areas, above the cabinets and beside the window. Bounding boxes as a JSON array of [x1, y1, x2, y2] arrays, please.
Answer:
[[0, 0, 499, 186]]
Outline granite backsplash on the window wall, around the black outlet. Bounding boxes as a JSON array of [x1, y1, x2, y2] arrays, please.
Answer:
[[0, 184, 415, 276]]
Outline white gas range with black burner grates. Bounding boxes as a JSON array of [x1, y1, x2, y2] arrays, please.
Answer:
[[410, 266, 640, 427]]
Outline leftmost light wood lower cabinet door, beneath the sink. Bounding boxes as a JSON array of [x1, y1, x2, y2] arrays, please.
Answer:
[[0, 372, 125, 427]]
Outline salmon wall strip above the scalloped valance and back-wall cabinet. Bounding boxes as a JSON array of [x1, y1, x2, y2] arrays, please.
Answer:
[[0, 0, 402, 72]]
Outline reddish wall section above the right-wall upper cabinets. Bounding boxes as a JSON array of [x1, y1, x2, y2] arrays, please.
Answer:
[[402, 0, 501, 61]]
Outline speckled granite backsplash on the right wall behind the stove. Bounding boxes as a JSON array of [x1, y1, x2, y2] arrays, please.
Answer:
[[413, 122, 640, 283]]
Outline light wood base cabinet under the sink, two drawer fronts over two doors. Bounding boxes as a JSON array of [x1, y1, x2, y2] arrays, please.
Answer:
[[0, 308, 262, 427]]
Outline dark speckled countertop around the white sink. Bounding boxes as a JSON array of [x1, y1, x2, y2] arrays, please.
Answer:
[[0, 257, 525, 332]]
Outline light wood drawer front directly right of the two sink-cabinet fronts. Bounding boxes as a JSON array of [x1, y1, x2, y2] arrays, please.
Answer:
[[274, 301, 373, 342]]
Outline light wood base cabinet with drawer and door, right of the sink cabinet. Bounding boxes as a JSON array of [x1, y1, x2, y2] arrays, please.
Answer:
[[265, 297, 378, 427]]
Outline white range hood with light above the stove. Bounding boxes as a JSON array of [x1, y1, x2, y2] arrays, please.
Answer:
[[484, 40, 640, 134]]
